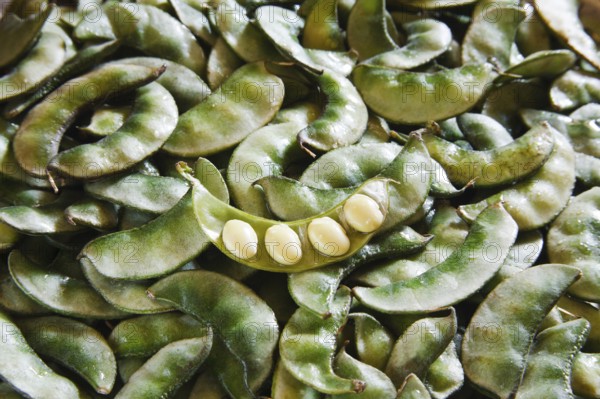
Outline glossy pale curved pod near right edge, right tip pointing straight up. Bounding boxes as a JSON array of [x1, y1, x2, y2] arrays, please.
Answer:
[[458, 131, 575, 230]]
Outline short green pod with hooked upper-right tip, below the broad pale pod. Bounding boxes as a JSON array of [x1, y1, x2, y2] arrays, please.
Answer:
[[385, 308, 457, 388]]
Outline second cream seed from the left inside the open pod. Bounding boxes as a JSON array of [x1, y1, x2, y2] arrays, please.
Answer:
[[265, 224, 302, 266]]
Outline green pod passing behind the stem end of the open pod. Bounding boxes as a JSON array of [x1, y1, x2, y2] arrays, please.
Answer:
[[80, 158, 229, 280]]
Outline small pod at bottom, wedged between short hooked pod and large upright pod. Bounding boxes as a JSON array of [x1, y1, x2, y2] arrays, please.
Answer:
[[423, 341, 465, 399]]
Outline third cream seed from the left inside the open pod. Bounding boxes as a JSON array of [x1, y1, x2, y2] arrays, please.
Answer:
[[308, 217, 350, 256]]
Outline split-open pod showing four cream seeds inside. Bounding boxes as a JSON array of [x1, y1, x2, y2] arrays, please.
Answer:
[[177, 162, 390, 273]]
